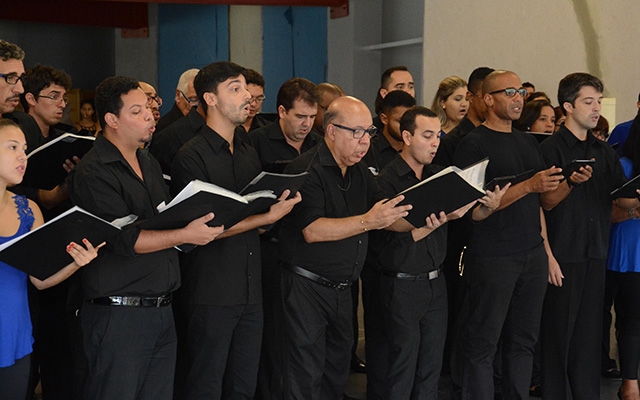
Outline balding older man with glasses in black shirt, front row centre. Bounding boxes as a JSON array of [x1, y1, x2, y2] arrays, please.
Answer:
[[280, 96, 410, 400]]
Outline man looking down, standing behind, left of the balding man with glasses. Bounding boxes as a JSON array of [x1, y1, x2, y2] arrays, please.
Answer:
[[249, 78, 322, 399]]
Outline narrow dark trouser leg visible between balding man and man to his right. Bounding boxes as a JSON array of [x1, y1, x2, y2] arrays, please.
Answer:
[[360, 258, 389, 400]]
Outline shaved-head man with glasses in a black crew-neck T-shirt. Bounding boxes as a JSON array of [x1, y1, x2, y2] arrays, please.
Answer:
[[454, 71, 562, 400]]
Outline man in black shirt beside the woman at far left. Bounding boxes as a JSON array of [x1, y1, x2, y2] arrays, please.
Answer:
[[70, 77, 222, 400]]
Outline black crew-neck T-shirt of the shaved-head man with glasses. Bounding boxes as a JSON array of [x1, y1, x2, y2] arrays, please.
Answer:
[[454, 125, 545, 257]]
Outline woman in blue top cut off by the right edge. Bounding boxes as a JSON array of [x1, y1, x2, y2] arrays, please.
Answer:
[[607, 114, 640, 400]]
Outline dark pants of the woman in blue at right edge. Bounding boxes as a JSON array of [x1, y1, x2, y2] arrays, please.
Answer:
[[607, 271, 640, 379]]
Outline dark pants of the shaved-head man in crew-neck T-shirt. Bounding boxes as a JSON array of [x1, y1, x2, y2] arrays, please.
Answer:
[[462, 245, 548, 400]]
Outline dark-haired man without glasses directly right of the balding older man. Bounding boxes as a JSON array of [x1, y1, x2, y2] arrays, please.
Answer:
[[378, 107, 478, 399]]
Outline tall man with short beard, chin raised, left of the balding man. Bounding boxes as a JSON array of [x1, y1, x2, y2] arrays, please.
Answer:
[[171, 61, 300, 399]]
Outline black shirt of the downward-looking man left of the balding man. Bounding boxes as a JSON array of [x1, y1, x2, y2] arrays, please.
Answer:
[[249, 121, 322, 172]]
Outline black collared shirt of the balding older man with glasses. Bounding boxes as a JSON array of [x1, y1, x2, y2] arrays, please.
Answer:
[[280, 142, 377, 281]]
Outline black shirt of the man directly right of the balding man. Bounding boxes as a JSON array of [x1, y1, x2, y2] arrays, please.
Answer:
[[377, 155, 447, 274]]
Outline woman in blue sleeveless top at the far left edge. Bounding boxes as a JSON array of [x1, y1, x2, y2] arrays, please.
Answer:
[[0, 119, 104, 400]]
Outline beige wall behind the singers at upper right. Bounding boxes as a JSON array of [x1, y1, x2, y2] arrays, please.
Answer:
[[423, 0, 640, 122]]
